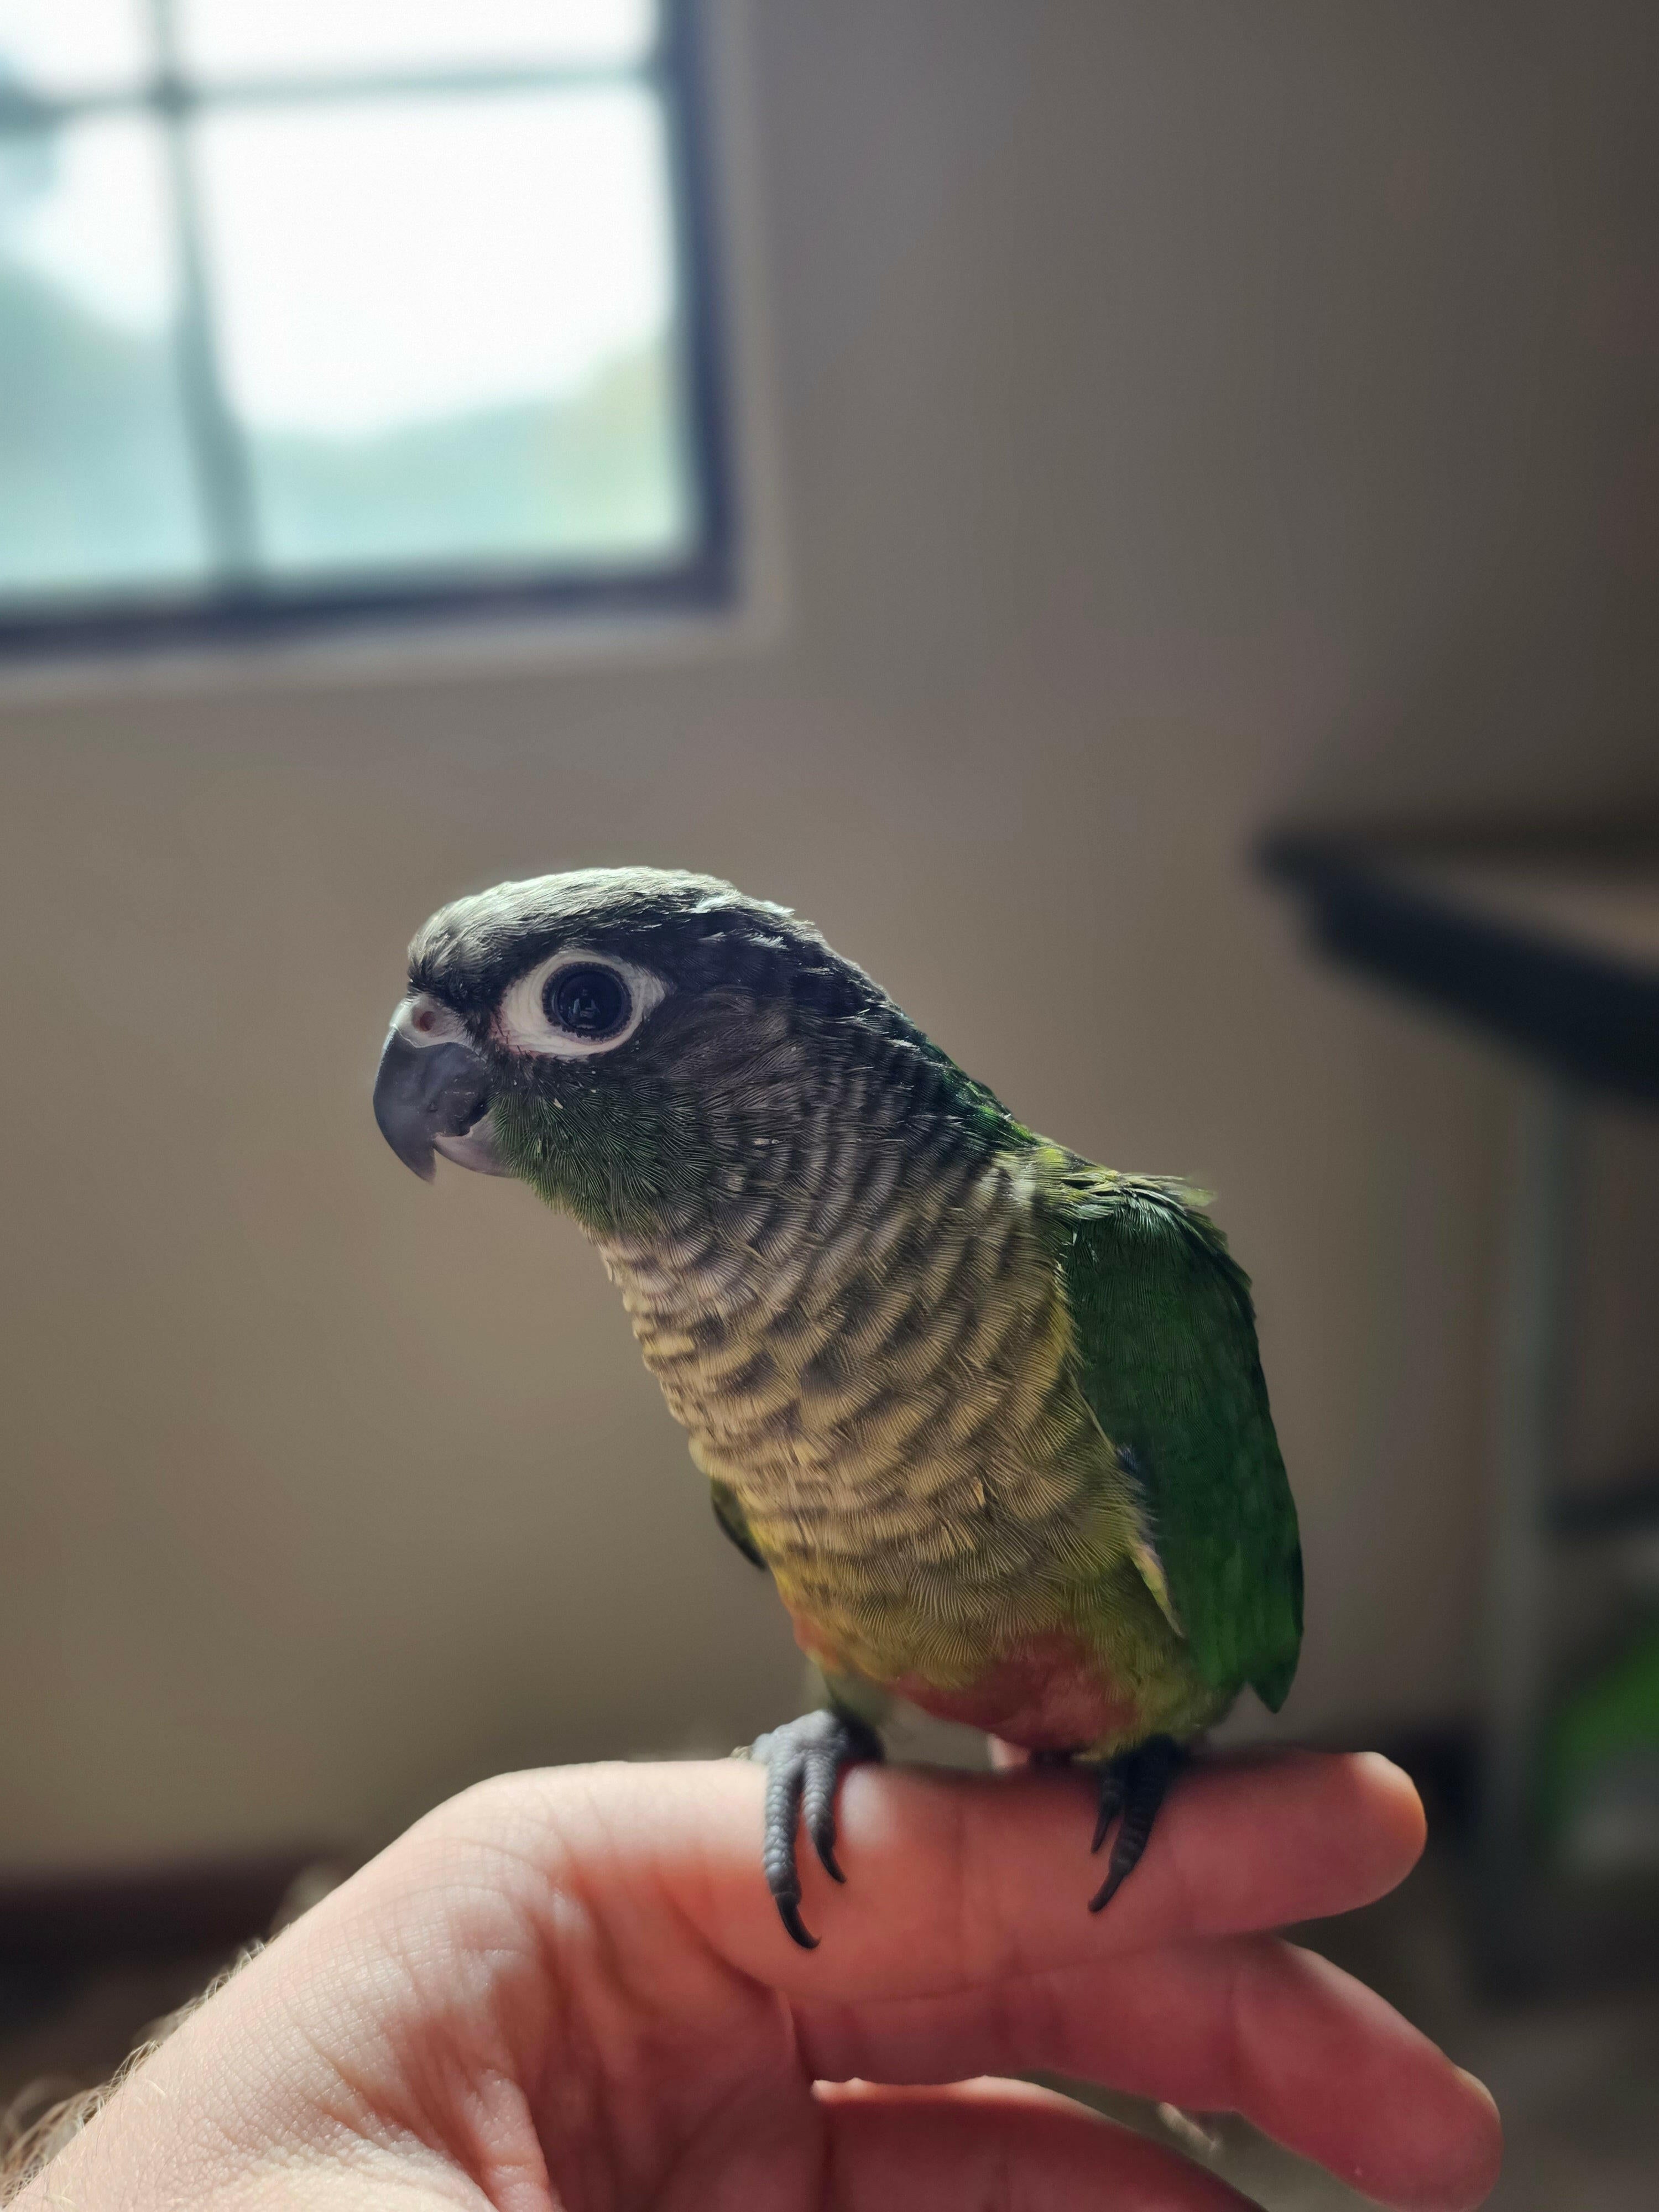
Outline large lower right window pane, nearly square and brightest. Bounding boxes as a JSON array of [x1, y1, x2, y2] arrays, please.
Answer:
[[199, 86, 692, 571]]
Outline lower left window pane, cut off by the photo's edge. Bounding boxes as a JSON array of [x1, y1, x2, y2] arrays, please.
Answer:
[[0, 117, 204, 595]]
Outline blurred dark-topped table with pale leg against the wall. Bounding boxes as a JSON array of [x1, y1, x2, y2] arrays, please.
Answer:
[[1261, 816, 1659, 1989]]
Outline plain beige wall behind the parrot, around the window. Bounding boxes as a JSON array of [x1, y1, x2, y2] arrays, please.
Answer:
[[0, 0, 1659, 1865]]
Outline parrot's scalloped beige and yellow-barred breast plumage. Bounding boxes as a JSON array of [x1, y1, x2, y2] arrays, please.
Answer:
[[595, 1044, 1137, 1683]]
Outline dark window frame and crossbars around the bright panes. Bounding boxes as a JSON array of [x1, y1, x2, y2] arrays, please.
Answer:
[[0, 0, 739, 666]]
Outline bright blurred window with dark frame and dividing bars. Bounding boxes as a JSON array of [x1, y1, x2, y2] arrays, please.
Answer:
[[0, 0, 730, 648]]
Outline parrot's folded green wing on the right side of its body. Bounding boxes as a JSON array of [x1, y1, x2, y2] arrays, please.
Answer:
[[1060, 1168, 1303, 1712]]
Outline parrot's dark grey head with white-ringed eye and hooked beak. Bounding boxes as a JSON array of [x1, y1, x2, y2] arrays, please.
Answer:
[[374, 867, 956, 1234]]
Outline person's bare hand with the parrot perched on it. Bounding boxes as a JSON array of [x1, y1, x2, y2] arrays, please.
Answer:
[[18, 1752, 1500, 2212]]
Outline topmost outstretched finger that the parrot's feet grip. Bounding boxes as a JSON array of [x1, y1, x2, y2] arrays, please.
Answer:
[[690, 1752, 1425, 2000]]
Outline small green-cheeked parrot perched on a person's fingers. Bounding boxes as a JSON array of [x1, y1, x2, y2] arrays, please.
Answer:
[[374, 867, 1303, 1949]]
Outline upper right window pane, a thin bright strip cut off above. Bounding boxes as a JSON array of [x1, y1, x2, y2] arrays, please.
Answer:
[[176, 0, 657, 80]]
